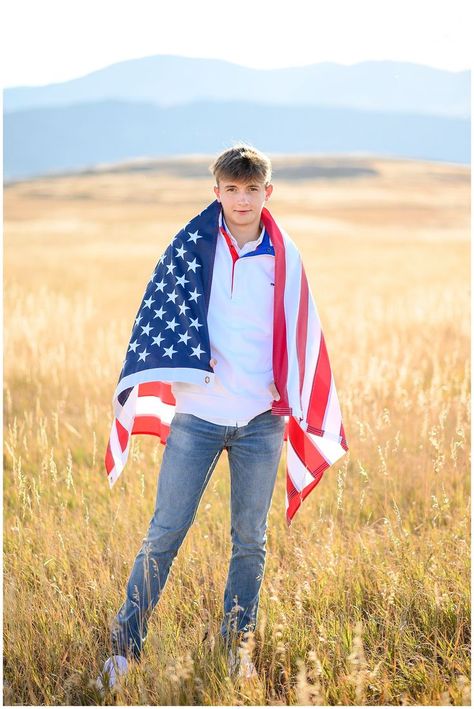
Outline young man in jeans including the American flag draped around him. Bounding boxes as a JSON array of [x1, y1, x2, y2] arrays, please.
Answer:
[[98, 144, 346, 686]]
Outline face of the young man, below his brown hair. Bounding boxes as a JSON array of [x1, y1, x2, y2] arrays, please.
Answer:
[[214, 178, 273, 231]]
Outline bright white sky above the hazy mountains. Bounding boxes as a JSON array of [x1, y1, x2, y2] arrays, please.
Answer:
[[0, 0, 473, 87]]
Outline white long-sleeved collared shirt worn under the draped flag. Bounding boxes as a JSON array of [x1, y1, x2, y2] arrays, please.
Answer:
[[172, 210, 275, 426]]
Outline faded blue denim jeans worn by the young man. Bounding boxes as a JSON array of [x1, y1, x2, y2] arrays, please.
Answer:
[[111, 410, 285, 660]]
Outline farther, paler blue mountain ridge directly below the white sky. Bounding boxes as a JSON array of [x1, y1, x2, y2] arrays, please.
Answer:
[[4, 55, 470, 118]]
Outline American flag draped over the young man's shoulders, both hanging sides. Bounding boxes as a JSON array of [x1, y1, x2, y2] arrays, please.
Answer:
[[105, 200, 348, 525]]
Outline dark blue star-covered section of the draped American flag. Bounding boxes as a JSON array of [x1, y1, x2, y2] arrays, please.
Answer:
[[119, 209, 218, 403]]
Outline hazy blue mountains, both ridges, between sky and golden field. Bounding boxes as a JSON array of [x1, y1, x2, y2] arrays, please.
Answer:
[[4, 56, 470, 181]]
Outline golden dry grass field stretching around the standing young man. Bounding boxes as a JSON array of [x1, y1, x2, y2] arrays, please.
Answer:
[[3, 156, 470, 706]]
